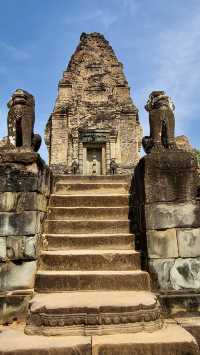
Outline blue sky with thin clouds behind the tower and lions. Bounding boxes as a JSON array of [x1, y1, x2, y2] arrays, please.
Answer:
[[0, 0, 200, 158]]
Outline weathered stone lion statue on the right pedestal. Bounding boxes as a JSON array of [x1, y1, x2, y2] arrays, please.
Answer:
[[142, 91, 175, 153]]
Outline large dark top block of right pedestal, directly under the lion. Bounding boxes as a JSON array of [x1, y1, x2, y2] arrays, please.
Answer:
[[136, 150, 198, 203]]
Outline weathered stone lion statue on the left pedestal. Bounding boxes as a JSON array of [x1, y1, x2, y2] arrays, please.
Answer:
[[7, 89, 41, 151]]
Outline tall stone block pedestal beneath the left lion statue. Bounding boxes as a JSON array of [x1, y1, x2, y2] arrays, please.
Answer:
[[0, 151, 49, 323]]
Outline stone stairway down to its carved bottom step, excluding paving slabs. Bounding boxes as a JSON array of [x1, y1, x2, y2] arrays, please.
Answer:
[[26, 176, 162, 335]]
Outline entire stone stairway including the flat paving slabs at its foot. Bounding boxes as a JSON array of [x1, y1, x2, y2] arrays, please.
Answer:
[[21, 176, 199, 355]]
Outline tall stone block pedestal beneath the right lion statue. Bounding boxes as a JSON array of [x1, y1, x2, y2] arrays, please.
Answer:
[[136, 150, 200, 316]]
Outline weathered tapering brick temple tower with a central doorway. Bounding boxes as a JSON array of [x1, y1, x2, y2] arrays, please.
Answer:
[[45, 33, 142, 175]]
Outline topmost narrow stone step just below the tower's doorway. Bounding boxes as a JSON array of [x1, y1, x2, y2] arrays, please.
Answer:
[[53, 175, 132, 184]]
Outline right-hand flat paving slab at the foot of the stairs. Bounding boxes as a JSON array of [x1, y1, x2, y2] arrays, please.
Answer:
[[92, 324, 199, 355]]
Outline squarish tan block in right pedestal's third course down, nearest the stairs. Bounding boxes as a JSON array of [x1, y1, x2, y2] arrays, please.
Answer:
[[147, 228, 178, 258]]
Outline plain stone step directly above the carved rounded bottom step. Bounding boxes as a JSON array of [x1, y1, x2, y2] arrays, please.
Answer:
[[35, 270, 150, 293]]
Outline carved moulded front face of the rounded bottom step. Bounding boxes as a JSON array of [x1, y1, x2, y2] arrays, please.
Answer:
[[26, 301, 163, 335]]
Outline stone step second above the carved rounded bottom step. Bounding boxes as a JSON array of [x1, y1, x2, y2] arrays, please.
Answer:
[[39, 249, 140, 271]]
